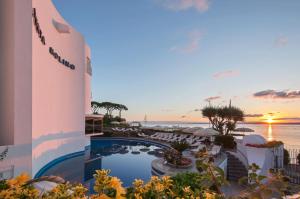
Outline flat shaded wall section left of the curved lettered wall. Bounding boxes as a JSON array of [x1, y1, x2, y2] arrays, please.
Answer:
[[0, 0, 32, 174]]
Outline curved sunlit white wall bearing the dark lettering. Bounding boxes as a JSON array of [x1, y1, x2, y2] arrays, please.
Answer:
[[32, 0, 89, 175]]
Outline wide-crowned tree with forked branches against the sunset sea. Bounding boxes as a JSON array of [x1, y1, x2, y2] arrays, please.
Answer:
[[202, 106, 244, 135]]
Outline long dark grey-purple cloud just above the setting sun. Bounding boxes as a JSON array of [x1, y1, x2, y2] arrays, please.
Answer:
[[253, 89, 300, 99]]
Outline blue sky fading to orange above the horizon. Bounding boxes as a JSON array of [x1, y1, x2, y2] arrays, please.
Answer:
[[53, 0, 300, 121]]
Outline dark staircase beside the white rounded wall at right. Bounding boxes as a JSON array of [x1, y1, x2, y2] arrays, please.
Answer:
[[226, 152, 248, 182]]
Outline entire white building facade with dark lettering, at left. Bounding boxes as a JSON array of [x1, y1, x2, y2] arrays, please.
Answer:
[[0, 0, 92, 177]]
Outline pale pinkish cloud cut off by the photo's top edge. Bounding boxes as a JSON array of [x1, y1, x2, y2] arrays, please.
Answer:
[[158, 0, 210, 12]]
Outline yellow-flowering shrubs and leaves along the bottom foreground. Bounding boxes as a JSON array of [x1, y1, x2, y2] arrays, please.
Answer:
[[0, 161, 298, 199]]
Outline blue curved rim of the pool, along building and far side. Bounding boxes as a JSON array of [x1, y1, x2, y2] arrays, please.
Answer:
[[34, 137, 170, 178]]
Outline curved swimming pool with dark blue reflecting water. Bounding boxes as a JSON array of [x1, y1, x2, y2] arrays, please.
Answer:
[[42, 138, 167, 192]]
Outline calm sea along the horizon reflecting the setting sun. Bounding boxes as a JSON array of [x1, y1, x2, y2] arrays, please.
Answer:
[[141, 121, 300, 149]]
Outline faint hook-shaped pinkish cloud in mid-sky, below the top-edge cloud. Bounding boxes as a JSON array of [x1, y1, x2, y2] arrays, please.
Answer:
[[170, 30, 203, 54]]
